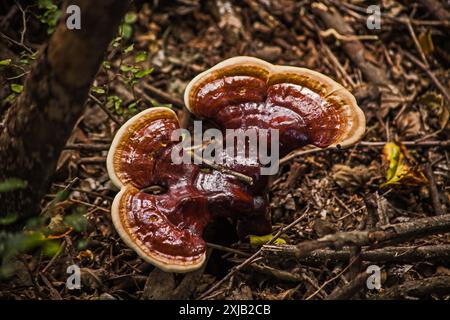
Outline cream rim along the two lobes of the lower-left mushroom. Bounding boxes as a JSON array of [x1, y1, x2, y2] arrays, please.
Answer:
[[106, 107, 206, 273]]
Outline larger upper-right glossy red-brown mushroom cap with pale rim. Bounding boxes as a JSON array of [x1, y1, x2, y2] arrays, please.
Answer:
[[184, 56, 365, 156]]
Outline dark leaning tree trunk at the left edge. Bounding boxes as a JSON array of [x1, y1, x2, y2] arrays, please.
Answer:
[[0, 0, 127, 218]]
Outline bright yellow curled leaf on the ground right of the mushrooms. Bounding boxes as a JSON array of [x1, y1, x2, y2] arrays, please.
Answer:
[[381, 142, 428, 187]]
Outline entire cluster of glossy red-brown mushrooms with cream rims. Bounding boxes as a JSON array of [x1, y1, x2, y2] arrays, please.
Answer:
[[107, 57, 365, 272]]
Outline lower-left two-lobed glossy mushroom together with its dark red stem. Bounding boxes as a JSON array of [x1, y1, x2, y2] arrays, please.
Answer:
[[107, 108, 270, 272]]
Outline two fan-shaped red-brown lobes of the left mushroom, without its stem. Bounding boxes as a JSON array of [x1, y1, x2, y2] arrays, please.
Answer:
[[107, 108, 209, 272]]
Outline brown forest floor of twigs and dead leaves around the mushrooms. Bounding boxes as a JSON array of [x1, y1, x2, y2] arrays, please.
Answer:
[[0, 0, 450, 299]]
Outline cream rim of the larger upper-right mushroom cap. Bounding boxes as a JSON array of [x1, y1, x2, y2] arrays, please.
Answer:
[[184, 56, 366, 148]]
